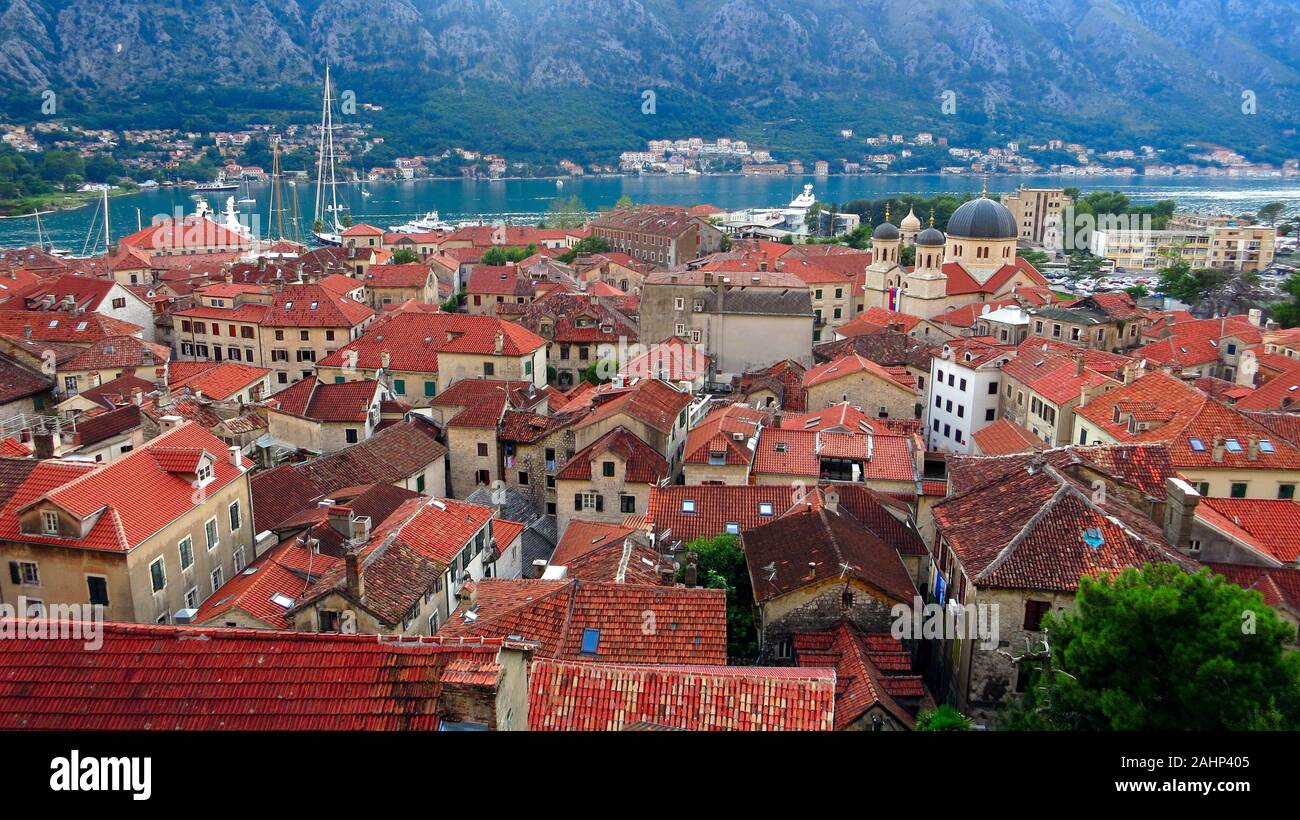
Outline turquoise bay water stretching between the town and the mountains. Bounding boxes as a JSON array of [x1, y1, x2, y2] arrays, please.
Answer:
[[0, 175, 1300, 253]]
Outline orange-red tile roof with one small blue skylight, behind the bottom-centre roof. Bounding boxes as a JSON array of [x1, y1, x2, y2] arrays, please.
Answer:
[[438, 578, 727, 664]]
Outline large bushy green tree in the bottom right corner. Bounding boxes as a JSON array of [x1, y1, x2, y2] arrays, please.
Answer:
[[1005, 564, 1300, 732]]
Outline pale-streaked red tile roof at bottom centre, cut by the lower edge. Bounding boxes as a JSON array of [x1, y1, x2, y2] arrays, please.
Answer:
[[528, 660, 835, 732]]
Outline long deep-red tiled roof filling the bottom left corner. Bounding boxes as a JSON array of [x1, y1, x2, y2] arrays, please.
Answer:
[[0, 624, 512, 732]]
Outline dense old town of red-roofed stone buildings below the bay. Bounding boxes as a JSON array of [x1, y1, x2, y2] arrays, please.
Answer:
[[0, 196, 1300, 732]]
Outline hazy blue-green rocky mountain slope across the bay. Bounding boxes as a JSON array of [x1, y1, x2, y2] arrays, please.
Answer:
[[0, 0, 1300, 160]]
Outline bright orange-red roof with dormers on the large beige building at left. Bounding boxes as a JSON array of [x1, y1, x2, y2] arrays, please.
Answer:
[[0, 422, 252, 552]]
